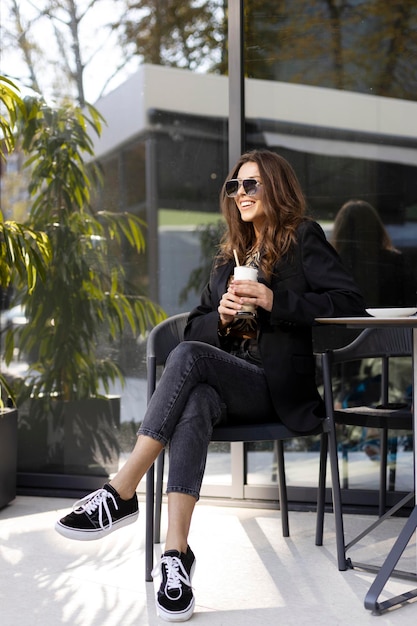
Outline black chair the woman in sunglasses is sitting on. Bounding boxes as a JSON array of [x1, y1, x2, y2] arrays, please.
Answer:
[[145, 313, 327, 581]]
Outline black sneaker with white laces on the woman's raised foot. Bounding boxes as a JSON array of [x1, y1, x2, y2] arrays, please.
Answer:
[[55, 484, 139, 541]]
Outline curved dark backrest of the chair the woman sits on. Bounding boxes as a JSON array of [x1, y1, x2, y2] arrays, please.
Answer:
[[146, 313, 189, 402]]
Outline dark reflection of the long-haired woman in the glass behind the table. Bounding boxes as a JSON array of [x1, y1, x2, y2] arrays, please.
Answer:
[[332, 199, 414, 448]]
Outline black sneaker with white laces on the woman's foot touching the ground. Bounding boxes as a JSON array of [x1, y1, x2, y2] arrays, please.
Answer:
[[152, 547, 195, 622]]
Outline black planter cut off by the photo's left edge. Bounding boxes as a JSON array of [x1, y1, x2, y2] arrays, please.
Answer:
[[0, 409, 17, 509]]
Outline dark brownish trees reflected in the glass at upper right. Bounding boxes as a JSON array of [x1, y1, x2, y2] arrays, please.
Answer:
[[244, 0, 417, 100]]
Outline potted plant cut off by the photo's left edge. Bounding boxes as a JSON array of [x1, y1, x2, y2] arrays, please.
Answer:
[[0, 76, 51, 508]]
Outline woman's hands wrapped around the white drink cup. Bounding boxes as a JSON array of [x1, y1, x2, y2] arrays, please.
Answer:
[[217, 280, 274, 326]]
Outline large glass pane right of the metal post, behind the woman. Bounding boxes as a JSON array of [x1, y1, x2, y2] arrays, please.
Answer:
[[244, 0, 417, 502]]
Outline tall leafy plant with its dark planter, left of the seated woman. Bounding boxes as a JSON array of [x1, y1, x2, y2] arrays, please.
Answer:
[[5, 92, 165, 491]]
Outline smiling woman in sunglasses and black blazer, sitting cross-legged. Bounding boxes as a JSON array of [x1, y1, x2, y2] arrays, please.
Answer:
[[56, 151, 364, 621]]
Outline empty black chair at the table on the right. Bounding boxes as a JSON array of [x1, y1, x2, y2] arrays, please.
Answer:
[[316, 327, 413, 571]]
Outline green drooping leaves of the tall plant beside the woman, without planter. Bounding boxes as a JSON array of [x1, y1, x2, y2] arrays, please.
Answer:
[[6, 95, 164, 401]]
